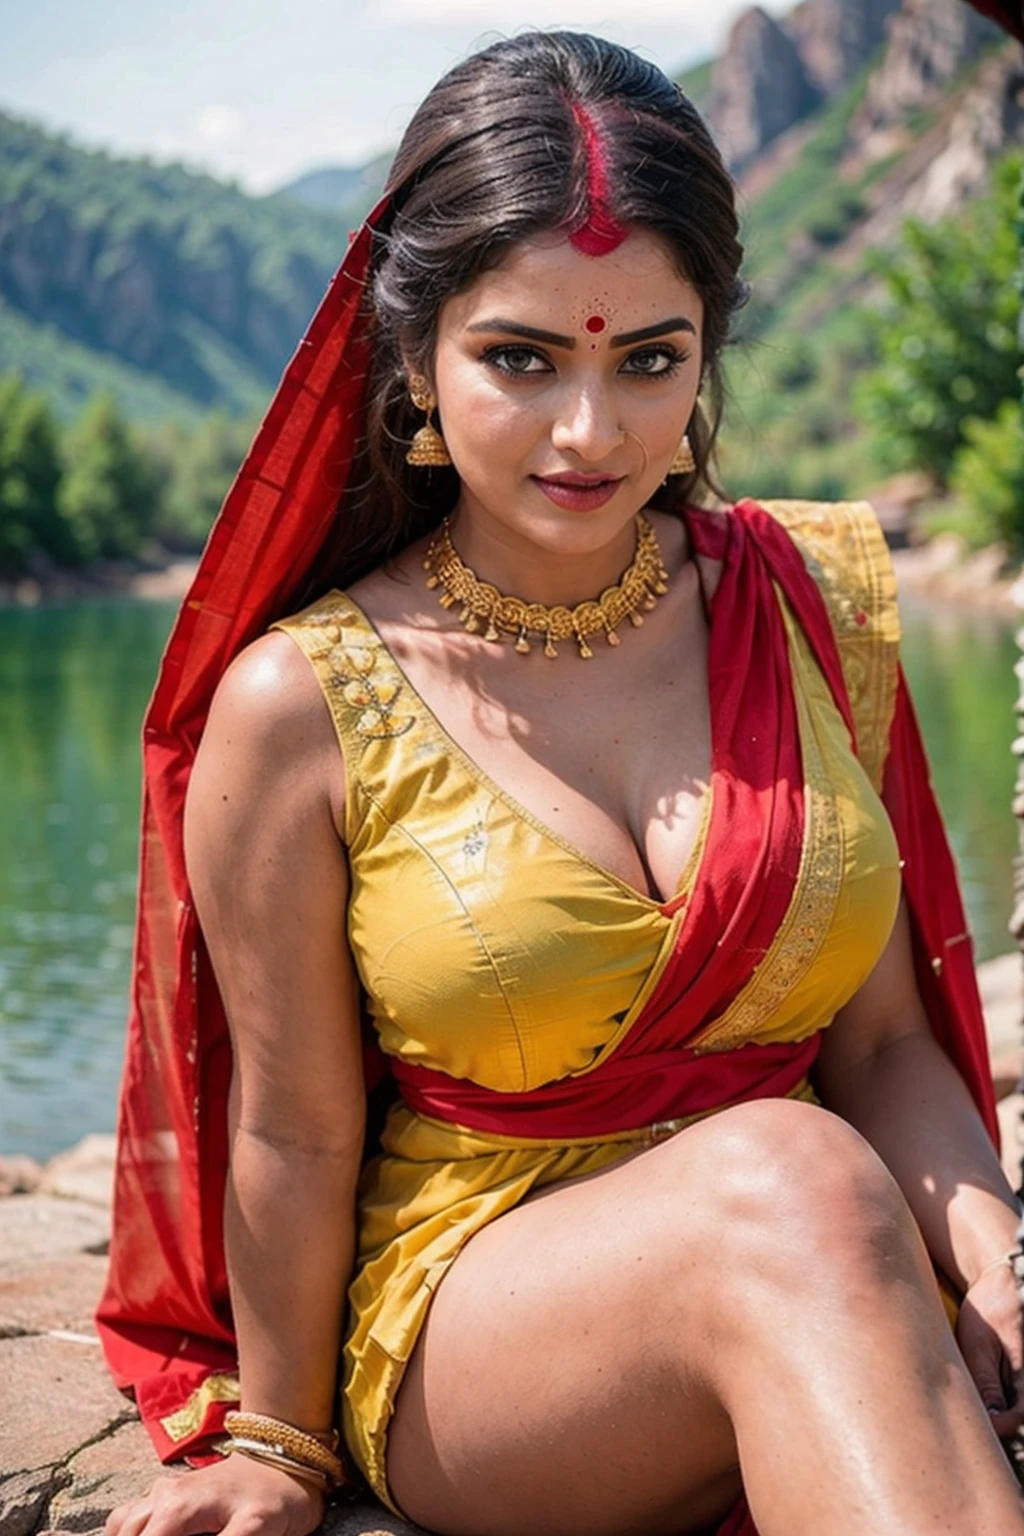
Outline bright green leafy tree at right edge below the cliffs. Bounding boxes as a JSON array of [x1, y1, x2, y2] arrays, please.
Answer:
[[857, 157, 1021, 485]]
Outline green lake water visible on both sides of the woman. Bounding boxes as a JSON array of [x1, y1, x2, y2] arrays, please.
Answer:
[[0, 599, 1015, 1158]]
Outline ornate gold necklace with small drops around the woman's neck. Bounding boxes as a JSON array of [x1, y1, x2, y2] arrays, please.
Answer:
[[424, 511, 668, 657]]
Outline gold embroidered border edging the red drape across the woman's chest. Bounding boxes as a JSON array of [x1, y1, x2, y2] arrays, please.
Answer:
[[692, 593, 846, 1051]]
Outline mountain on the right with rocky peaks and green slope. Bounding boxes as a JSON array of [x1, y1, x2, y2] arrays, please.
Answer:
[[725, 0, 1024, 498]]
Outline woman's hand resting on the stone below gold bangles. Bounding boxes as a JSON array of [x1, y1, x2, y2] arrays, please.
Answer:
[[104, 1456, 324, 1536]]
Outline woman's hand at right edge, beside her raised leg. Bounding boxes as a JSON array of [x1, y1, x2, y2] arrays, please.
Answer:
[[956, 1264, 1024, 1436]]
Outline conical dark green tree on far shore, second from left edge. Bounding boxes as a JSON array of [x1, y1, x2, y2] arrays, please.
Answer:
[[58, 395, 161, 559]]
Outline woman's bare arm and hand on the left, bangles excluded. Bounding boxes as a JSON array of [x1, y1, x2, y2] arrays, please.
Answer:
[[107, 634, 364, 1536]]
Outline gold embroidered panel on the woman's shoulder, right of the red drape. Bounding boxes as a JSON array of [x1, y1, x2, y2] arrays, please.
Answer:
[[760, 501, 900, 791]]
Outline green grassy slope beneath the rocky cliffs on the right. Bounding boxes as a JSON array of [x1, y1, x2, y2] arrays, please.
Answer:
[[722, 42, 1007, 499]]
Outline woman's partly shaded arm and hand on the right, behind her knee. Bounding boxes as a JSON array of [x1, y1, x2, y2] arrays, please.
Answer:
[[818, 903, 1021, 1428]]
